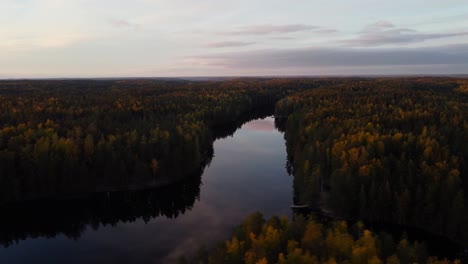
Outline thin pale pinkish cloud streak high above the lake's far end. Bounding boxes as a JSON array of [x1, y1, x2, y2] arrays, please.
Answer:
[[223, 24, 318, 35]]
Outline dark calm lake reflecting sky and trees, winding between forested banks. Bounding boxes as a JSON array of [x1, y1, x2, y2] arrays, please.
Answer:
[[0, 117, 293, 263]]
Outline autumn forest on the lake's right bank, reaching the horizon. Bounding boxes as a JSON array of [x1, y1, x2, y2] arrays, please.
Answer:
[[277, 79, 468, 246]]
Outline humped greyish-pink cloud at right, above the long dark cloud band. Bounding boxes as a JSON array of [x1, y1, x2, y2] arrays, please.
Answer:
[[343, 21, 468, 47]]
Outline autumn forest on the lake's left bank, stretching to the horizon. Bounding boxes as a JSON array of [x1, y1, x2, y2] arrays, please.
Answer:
[[0, 79, 328, 203]]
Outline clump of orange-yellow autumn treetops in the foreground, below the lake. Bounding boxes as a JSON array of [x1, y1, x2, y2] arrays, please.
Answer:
[[179, 213, 461, 264]]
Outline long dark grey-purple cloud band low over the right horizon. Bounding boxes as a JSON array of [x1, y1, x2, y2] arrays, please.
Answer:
[[187, 44, 468, 69]]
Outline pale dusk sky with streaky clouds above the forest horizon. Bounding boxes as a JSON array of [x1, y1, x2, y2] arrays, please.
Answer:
[[0, 0, 468, 78]]
